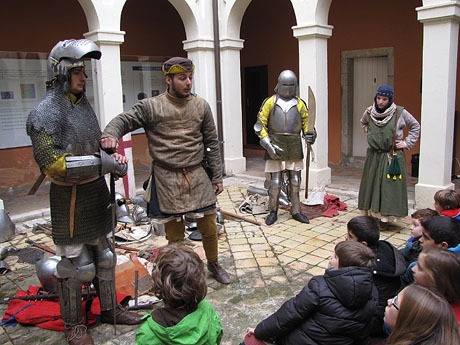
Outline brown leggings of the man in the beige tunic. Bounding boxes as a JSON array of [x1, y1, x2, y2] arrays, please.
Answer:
[[165, 214, 217, 262]]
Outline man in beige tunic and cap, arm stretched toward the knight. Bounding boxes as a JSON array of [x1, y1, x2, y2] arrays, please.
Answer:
[[101, 57, 230, 284]]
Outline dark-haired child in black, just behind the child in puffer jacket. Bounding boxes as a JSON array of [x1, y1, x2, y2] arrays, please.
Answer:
[[347, 216, 406, 337]]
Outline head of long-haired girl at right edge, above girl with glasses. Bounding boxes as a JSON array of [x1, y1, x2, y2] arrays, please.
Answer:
[[414, 247, 460, 322]]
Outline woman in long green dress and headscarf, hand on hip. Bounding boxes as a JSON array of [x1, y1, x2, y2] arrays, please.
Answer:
[[358, 85, 420, 228]]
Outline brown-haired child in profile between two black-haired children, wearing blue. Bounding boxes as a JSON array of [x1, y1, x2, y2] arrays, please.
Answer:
[[400, 208, 439, 266]]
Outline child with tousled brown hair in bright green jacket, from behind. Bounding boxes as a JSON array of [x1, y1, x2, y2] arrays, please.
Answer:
[[136, 244, 222, 345]]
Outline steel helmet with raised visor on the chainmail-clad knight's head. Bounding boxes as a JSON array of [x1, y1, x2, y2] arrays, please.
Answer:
[[48, 39, 102, 80]]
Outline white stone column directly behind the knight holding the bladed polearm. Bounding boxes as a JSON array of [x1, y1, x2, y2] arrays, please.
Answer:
[[292, 25, 332, 189]]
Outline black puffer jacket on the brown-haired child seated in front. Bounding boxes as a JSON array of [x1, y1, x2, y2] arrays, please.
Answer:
[[254, 267, 378, 345]]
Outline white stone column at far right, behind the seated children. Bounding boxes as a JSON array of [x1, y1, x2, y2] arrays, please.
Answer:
[[415, 1, 460, 209]]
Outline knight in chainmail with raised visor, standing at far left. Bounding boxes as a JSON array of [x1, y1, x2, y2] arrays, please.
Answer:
[[27, 39, 140, 344]]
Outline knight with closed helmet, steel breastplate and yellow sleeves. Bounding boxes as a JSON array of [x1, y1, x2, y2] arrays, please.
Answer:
[[254, 70, 316, 225]]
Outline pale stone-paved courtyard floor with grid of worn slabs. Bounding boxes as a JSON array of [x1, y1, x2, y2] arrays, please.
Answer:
[[0, 178, 410, 345]]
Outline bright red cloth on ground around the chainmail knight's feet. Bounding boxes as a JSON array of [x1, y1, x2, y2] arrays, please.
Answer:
[[2, 286, 130, 331]]
